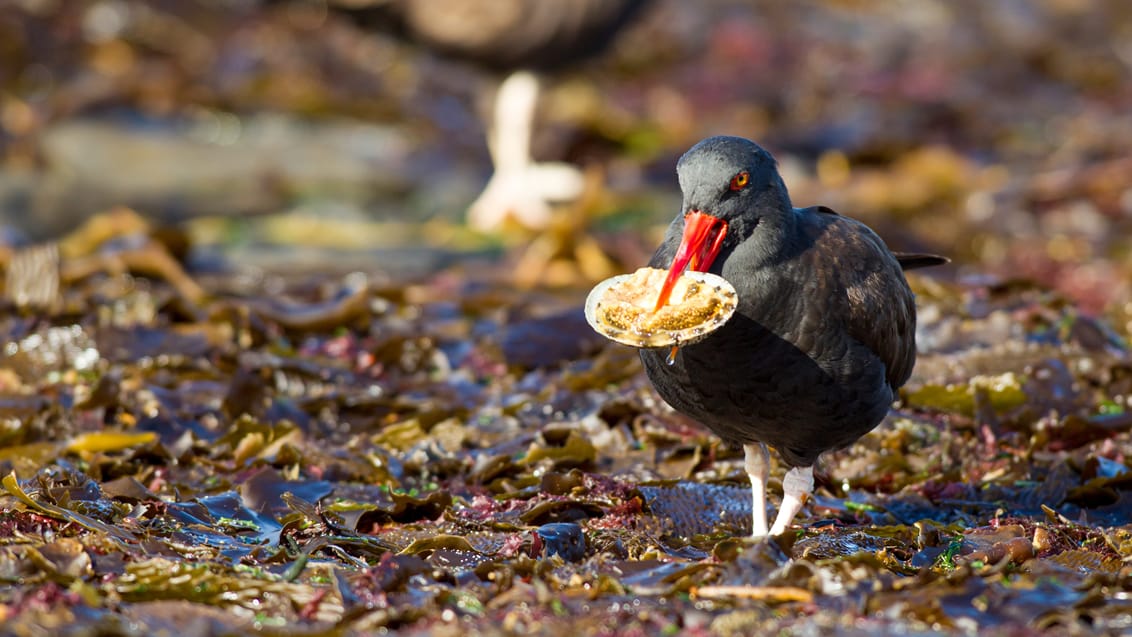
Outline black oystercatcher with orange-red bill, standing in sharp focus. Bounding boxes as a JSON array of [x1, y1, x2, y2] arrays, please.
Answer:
[[641, 137, 946, 536]]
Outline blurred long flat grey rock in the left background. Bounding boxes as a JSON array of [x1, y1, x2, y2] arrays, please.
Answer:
[[14, 113, 408, 236]]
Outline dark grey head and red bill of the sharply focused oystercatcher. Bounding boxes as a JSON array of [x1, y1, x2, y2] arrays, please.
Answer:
[[657, 137, 794, 308]]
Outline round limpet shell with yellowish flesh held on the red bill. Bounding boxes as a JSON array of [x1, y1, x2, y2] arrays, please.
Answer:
[[585, 268, 739, 347]]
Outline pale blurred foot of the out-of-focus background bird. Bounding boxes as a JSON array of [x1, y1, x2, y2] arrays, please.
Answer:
[[468, 163, 585, 231]]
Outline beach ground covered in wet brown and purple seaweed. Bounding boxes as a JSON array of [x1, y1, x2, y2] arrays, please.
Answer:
[[0, 0, 1132, 635]]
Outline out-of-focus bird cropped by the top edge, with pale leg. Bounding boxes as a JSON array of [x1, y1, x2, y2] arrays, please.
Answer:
[[287, 0, 648, 230]]
